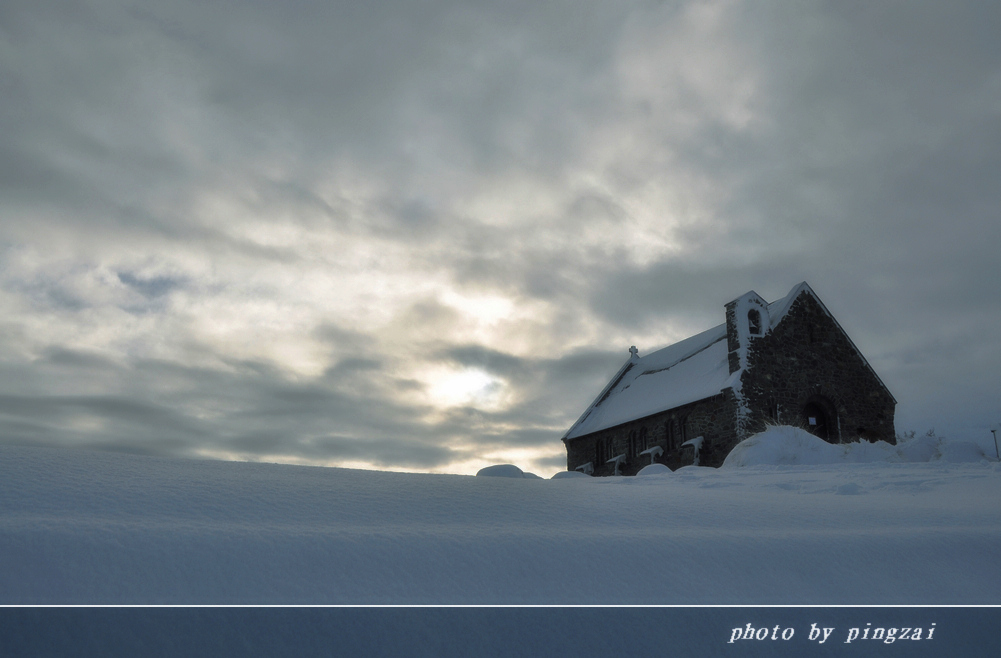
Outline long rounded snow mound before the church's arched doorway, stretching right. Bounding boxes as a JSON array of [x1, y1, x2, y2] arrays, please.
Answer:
[[722, 426, 987, 468]]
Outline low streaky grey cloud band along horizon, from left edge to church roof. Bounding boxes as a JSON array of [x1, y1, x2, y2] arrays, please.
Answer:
[[0, 326, 623, 469]]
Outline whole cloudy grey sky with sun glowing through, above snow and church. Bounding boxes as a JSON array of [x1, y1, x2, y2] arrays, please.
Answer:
[[0, 0, 1001, 475]]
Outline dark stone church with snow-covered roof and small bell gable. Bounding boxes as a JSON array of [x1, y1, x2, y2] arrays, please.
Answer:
[[563, 281, 897, 476]]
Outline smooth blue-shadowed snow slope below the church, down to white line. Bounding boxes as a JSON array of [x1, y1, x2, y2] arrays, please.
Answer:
[[0, 447, 1001, 604]]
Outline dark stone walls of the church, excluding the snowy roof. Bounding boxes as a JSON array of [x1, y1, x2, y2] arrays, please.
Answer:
[[565, 286, 896, 476]]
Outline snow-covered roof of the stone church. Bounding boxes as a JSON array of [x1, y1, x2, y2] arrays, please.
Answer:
[[564, 281, 886, 439]]
